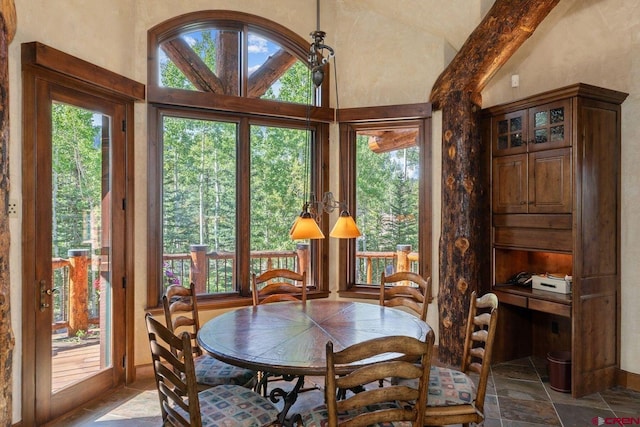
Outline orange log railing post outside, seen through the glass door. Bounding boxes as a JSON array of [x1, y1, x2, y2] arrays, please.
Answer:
[[68, 249, 89, 336]]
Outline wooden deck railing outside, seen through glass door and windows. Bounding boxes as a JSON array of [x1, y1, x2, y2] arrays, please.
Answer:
[[52, 243, 419, 336]]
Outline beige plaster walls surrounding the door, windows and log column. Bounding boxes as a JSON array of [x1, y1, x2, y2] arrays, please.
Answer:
[[9, 0, 640, 422]]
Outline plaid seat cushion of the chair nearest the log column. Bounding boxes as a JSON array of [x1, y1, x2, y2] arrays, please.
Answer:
[[427, 366, 476, 406]]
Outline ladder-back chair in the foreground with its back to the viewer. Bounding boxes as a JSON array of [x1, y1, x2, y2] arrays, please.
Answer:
[[302, 330, 435, 427]]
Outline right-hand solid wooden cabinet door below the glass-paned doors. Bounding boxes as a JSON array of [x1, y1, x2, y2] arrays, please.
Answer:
[[529, 148, 573, 213]]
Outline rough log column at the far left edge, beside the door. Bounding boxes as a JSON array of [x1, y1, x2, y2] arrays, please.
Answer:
[[0, 0, 16, 425]]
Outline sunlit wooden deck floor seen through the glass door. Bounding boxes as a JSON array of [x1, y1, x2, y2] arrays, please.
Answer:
[[51, 342, 100, 392]]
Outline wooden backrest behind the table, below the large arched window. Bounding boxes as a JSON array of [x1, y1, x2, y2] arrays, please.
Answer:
[[251, 268, 307, 305]]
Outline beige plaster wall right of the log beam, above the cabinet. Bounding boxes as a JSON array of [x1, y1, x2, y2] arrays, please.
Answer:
[[482, 0, 640, 374]]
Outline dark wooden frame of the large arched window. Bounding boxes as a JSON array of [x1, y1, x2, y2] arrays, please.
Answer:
[[146, 10, 334, 309]]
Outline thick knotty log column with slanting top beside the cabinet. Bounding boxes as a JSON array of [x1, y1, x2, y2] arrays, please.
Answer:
[[430, 0, 560, 365]]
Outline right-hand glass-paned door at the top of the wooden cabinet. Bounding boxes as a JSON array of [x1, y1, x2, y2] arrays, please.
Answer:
[[527, 99, 571, 152]]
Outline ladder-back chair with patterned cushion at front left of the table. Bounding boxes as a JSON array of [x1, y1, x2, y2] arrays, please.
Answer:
[[146, 314, 278, 427]]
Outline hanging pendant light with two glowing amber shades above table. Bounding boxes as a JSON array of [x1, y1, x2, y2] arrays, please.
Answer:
[[289, 0, 362, 240]]
